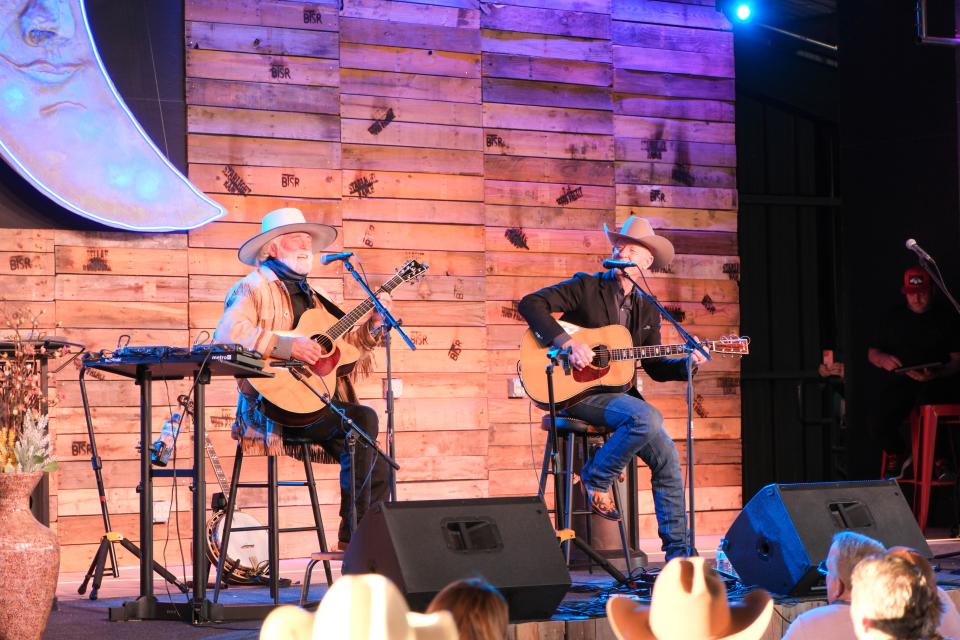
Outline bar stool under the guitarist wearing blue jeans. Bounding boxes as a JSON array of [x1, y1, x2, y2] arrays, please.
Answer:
[[539, 414, 633, 573]]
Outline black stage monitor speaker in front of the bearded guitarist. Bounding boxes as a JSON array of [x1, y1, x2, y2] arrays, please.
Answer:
[[343, 496, 570, 621]]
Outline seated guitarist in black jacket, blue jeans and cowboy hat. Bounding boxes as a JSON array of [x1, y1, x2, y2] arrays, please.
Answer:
[[518, 216, 705, 560]]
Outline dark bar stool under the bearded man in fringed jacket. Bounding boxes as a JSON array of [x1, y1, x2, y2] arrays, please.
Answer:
[[213, 443, 333, 604]]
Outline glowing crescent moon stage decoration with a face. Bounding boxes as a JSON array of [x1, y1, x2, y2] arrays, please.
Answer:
[[0, 0, 226, 231]]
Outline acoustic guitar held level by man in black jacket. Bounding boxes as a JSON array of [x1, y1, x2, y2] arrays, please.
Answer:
[[517, 322, 750, 409]]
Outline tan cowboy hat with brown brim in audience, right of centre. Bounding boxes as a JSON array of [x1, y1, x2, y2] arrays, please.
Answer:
[[607, 558, 773, 640]]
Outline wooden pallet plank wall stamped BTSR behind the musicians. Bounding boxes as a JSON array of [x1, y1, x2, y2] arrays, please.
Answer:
[[11, 0, 741, 570]]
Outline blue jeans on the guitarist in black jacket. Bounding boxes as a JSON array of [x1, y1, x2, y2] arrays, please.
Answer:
[[564, 393, 687, 560]]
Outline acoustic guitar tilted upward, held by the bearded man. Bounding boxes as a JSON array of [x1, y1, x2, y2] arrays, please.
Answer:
[[249, 260, 429, 414]]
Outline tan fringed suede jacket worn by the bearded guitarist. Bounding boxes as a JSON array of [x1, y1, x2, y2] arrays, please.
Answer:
[[214, 266, 378, 461]]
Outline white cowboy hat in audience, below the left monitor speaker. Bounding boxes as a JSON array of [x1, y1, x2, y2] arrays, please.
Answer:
[[260, 574, 457, 640]]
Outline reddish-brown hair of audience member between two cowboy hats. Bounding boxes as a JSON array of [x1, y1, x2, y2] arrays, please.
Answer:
[[427, 578, 510, 640]]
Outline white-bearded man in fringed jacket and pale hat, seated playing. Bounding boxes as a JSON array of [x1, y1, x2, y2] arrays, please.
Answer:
[[214, 208, 390, 548]]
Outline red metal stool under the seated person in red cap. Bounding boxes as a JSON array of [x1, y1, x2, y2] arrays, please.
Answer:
[[900, 404, 960, 530]]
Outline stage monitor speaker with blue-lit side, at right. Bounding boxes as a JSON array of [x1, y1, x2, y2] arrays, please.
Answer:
[[726, 480, 932, 596]]
